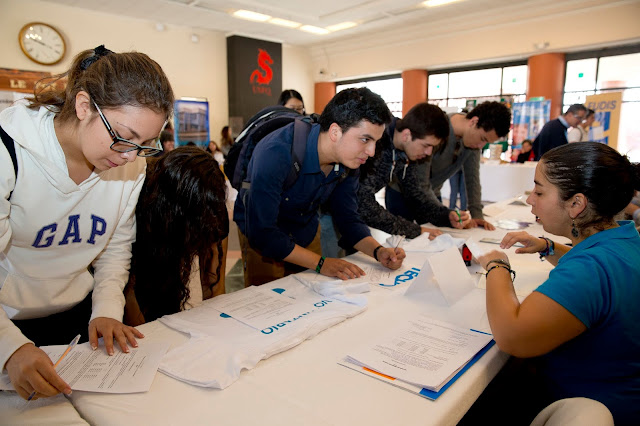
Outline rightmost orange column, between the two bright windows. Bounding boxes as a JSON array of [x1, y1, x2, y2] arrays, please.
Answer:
[[527, 53, 565, 119]]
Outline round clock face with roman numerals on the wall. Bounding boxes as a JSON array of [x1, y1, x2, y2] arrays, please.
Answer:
[[18, 22, 65, 65]]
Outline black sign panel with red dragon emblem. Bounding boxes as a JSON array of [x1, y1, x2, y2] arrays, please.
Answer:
[[227, 36, 282, 135]]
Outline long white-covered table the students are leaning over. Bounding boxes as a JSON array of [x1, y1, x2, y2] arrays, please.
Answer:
[[0, 204, 551, 425]]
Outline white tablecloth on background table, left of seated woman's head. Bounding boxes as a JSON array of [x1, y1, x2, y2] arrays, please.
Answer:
[[440, 161, 538, 203]]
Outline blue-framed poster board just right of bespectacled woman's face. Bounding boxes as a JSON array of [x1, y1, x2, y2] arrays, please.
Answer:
[[173, 99, 210, 148]]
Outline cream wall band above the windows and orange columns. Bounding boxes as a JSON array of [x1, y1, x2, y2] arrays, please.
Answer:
[[311, 0, 640, 81]]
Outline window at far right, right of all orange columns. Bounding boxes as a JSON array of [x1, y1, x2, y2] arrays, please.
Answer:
[[562, 45, 640, 162]]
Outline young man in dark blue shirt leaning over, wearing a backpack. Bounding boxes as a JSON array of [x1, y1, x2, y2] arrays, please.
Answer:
[[233, 88, 405, 286]]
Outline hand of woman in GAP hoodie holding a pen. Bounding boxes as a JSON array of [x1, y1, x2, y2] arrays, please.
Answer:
[[5, 343, 71, 400]]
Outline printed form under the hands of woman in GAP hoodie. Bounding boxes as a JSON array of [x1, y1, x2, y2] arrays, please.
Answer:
[[0, 340, 169, 393]]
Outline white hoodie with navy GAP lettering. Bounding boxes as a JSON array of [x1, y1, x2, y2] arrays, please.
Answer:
[[0, 103, 146, 369]]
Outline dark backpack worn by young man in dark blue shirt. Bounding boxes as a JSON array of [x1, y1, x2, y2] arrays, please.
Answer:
[[224, 105, 317, 190]]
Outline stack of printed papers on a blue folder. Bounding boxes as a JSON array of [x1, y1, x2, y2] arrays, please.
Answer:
[[340, 315, 493, 399]]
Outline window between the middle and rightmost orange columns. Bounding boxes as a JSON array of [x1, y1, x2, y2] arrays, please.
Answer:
[[428, 62, 528, 111]]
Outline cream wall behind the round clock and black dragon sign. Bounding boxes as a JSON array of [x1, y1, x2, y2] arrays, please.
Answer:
[[0, 0, 314, 140]]
